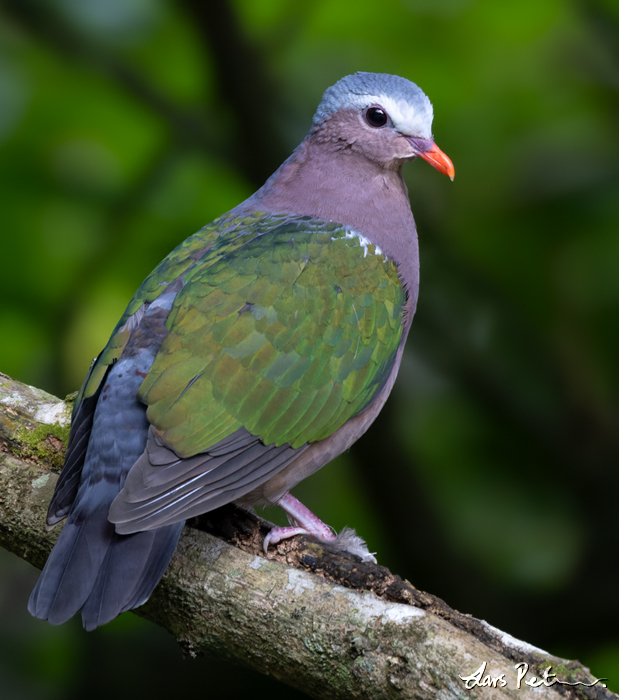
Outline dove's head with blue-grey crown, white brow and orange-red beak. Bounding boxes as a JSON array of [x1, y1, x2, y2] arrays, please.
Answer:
[[312, 73, 454, 180]]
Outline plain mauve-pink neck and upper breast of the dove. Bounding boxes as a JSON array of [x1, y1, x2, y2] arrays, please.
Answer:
[[233, 110, 419, 328]]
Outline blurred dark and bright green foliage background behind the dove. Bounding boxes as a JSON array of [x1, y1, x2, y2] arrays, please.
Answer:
[[0, 0, 619, 700]]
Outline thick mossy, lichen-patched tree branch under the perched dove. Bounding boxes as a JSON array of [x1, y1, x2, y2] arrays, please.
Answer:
[[0, 374, 619, 700]]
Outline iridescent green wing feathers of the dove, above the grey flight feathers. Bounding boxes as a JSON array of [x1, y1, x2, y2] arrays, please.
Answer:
[[138, 214, 406, 457]]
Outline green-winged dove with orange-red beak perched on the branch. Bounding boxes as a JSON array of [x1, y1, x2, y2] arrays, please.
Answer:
[[29, 72, 454, 630]]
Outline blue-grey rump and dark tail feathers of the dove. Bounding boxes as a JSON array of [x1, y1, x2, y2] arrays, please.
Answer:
[[28, 354, 183, 630]]
